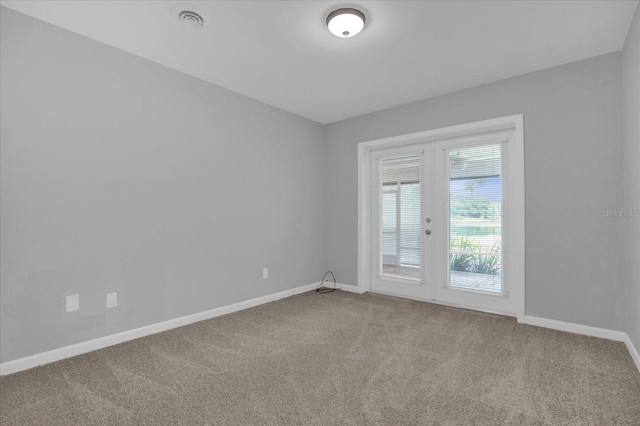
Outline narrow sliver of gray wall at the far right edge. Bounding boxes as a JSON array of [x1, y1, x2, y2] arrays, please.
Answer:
[[620, 6, 640, 350]]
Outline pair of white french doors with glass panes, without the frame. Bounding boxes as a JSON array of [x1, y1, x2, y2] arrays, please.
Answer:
[[370, 130, 523, 315]]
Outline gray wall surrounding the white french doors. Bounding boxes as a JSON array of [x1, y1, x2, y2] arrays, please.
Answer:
[[326, 52, 627, 330]]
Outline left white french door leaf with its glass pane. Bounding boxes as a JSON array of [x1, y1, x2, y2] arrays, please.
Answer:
[[371, 143, 435, 299]]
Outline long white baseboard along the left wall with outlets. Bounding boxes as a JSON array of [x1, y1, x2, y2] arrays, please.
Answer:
[[0, 282, 320, 376]]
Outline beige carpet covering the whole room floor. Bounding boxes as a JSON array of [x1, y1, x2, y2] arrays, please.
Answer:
[[0, 292, 640, 426]]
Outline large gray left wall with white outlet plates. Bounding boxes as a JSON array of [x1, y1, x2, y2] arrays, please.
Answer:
[[0, 8, 326, 362]]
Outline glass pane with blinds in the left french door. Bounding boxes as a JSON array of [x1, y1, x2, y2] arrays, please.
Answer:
[[380, 155, 422, 280]]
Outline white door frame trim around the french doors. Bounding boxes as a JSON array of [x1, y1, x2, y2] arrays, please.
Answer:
[[358, 114, 525, 322]]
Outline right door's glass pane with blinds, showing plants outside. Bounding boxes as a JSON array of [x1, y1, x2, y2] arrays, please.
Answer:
[[449, 144, 503, 293]]
